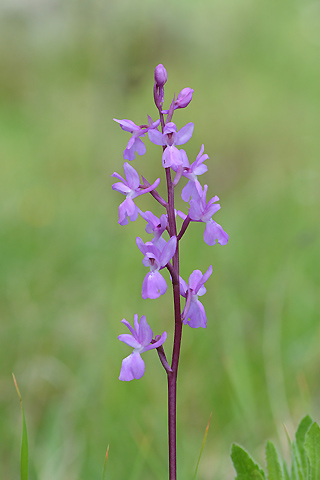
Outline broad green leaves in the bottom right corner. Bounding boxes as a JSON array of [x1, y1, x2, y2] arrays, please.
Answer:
[[231, 415, 320, 480]]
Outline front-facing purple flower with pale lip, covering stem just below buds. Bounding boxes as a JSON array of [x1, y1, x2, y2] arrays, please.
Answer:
[[148, 122, 194, 168]]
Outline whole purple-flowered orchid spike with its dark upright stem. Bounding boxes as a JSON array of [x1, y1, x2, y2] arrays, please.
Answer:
[[112, 64, 229, 480]]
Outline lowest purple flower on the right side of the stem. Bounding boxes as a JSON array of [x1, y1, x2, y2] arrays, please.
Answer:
[[180, 265, 212, 328]]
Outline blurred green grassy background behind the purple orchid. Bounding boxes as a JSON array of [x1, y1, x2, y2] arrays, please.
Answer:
[[0, 0, 320, 480]]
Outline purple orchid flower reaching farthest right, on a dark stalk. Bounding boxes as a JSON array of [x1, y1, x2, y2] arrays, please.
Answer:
[[189, 185, 229, 245]]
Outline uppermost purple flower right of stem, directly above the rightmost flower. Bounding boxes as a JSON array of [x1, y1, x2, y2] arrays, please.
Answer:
[[173, 145, 209, 202]]
